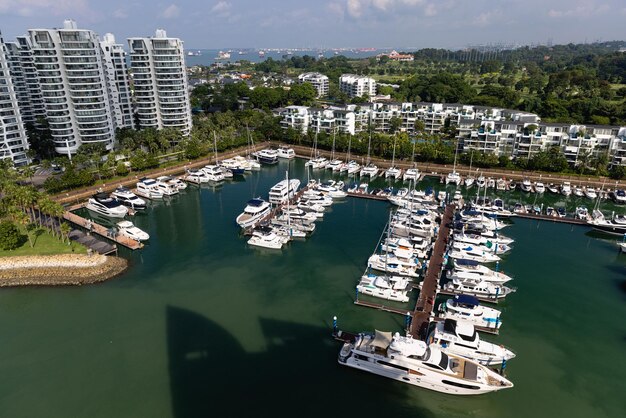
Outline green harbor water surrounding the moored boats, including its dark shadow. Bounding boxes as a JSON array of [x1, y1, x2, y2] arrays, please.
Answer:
[[0, 161, 626, 418]]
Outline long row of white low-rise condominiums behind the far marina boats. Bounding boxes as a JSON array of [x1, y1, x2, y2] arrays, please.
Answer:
[[276, 103, 626, 166]]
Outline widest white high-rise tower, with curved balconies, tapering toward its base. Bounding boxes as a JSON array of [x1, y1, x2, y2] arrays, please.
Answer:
[[28, 20, 131, 156]]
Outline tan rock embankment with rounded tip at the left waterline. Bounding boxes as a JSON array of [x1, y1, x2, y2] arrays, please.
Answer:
[[0, 254, 128, 287]]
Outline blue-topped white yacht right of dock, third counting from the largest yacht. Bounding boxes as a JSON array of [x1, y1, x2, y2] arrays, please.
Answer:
[[438, 295, 502, 329]]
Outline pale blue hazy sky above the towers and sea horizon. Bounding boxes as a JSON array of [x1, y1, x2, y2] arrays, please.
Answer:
[[0, 0, 626, 49]]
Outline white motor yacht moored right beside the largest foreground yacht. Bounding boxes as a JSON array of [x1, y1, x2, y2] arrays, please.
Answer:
[[428, 319, 515, 366]]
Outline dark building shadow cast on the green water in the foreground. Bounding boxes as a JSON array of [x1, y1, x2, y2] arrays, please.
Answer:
[[166, 306, 433, 418]]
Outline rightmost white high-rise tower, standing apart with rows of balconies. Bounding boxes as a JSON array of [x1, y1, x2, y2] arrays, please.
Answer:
[[128, 29, 191, 135]]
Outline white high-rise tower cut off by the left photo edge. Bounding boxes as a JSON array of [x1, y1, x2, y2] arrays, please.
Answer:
[[0, 34, 28, 166]]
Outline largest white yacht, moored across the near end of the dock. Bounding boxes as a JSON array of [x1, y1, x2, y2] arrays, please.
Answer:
[[337, 331, 513, 395]]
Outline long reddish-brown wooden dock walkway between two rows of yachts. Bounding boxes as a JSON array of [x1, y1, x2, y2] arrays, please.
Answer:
[[409, 205, 456, 338]]
